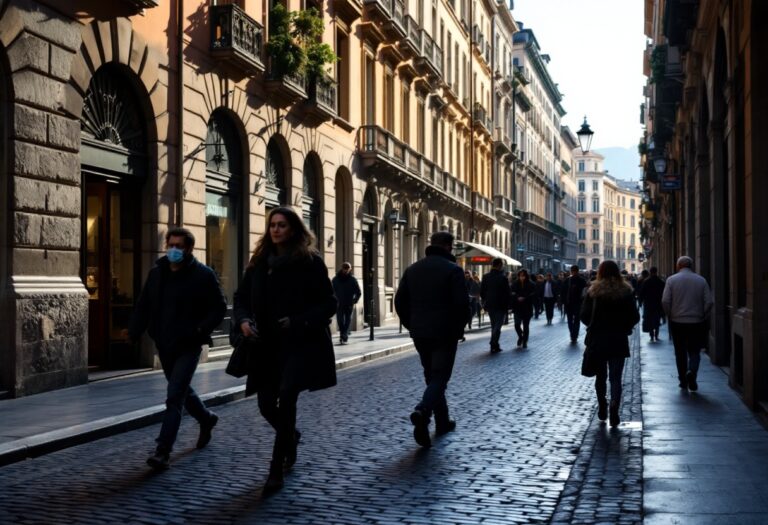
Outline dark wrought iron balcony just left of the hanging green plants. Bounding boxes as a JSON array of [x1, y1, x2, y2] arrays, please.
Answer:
[[209, 4, 264, 73]]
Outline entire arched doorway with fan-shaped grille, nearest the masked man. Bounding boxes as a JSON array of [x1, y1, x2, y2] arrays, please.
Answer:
[[80, 64, 147, 370]]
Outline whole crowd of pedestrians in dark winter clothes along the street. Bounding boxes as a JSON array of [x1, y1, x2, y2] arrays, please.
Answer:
[[126, 212, 712, 493]]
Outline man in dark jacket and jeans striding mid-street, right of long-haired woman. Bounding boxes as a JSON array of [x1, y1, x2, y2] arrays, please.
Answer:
[[395, 231, 469, 447]]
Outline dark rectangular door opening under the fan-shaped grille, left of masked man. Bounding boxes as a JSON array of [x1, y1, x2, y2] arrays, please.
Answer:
[[82, 176, 141, 371]]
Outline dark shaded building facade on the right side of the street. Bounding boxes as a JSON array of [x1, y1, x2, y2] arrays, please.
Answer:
[[640, 0, 768, 417]]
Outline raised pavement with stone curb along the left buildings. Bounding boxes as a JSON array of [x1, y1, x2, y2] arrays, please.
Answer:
[[0, 326, 432, 466]]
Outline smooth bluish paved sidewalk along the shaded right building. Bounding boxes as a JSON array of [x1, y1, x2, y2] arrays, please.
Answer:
[[641, 326, 768, 525]]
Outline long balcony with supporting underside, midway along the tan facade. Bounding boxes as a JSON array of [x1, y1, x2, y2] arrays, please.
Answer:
[[357, 125, 471, 208]]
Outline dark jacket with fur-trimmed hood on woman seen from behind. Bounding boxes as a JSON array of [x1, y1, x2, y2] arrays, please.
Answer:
[[580, 280, 640, 359]]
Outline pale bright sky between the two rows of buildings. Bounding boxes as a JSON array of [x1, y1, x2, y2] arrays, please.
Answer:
[[512, 0, 645, 148]]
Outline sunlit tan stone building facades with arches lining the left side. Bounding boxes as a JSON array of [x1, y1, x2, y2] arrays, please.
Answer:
[[0, 0, 566, 396]]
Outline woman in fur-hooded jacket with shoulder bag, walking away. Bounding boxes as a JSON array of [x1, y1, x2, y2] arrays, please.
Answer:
[[581, 260, 640, 427]]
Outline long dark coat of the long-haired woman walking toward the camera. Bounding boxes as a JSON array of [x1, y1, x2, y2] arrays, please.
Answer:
[[233, 255, 336, 395]]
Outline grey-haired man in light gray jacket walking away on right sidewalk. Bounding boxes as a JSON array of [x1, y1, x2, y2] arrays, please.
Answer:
[[661, 255, 712, 392]]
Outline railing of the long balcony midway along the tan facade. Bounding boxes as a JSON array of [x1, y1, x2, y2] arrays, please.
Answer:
[[357, 126, 471, 207]]
